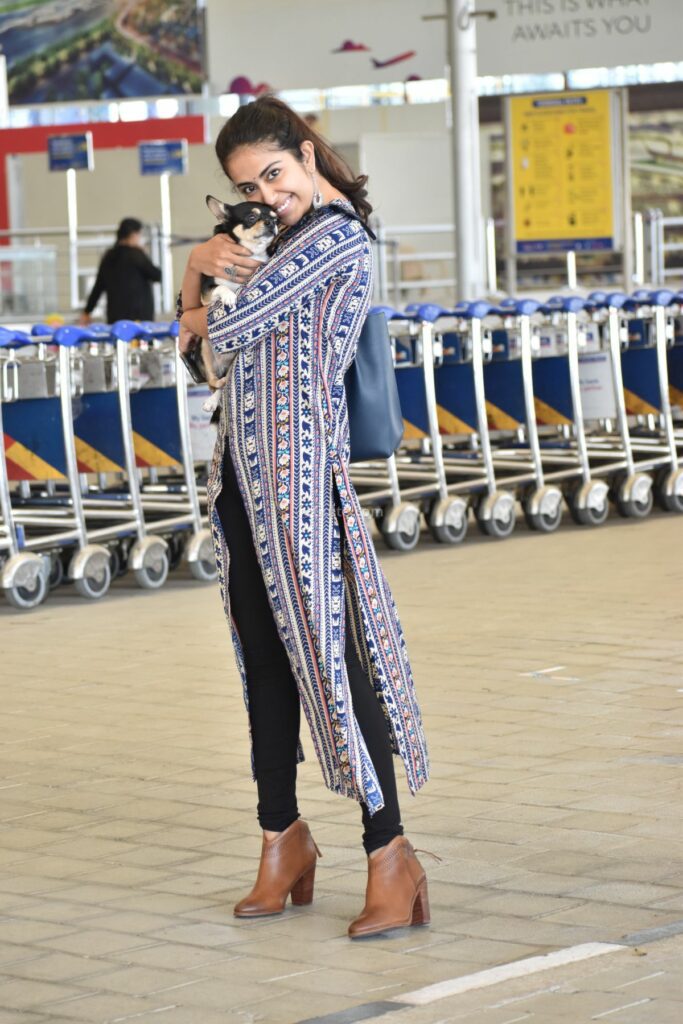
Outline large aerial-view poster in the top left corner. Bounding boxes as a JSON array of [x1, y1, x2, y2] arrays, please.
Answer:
[[0, 0, 203, 104]]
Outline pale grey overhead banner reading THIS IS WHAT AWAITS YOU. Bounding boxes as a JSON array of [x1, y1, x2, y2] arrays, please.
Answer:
[[477, 0, 683, 76]]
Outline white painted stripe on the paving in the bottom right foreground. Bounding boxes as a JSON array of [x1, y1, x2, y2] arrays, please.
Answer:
[[389, 942, 629, 1007]]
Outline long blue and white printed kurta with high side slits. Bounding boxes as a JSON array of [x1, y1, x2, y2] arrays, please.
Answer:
[[208, 200, 428, 813]]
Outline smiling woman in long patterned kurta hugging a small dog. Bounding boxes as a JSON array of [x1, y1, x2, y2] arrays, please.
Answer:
[[179, 96, 429, 938]]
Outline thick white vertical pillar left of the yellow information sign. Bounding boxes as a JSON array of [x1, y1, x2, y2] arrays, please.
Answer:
[[446, 0, 486, 300]]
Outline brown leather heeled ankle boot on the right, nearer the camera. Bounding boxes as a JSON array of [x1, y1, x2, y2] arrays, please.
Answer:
[[348, 836, 429, 939]]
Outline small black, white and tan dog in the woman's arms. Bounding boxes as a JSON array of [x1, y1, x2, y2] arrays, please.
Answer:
[[186, 196, 278, 413]]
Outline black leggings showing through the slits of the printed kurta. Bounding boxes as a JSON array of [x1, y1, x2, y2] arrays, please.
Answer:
[[216, 445, 403, 853]]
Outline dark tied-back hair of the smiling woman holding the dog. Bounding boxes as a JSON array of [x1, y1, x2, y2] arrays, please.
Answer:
[[216, 96, 373, 223]]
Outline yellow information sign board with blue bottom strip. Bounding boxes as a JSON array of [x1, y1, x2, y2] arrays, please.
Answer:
[[508, 89, 614, 253]]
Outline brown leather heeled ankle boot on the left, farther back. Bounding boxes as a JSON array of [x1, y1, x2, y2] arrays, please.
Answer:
[[233, 818, 323, 918]]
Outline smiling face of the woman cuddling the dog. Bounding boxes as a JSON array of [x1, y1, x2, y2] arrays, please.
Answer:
[[225, 142, 315, 227]]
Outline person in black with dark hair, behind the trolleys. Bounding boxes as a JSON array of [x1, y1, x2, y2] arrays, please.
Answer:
[[80, 217, 161, 325]]
